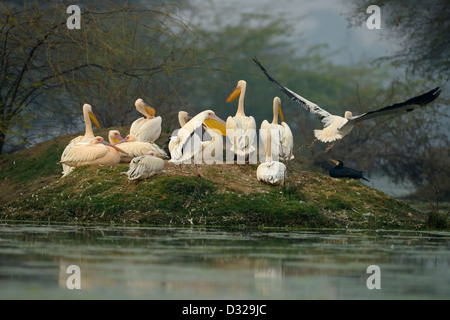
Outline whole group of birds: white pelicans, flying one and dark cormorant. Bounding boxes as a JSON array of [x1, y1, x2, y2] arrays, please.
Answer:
[[59, 58, 441, 189]]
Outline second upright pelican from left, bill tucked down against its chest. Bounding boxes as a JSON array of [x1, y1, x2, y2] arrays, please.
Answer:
[[130, 98, 162, 142]]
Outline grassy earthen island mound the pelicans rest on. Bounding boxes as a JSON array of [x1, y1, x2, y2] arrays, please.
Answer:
[[0, 128, 429, 230]]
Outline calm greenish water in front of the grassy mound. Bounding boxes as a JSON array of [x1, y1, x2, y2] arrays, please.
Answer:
[[0, 222, 450, 300]]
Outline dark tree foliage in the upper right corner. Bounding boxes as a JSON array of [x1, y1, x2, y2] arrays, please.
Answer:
[[348, 0, 450, 81]]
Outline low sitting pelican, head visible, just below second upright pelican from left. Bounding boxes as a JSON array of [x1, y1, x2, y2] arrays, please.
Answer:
[[108, 130, 167, 162]]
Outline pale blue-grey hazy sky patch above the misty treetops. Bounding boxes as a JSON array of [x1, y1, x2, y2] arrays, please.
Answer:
[[188, 0, 396, 64]]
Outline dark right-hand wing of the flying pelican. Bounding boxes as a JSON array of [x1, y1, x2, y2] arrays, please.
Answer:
[[348, 87, 441, 124]]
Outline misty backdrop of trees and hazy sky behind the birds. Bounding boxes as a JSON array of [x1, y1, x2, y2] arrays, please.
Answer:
[[0, 0, 450, 201]]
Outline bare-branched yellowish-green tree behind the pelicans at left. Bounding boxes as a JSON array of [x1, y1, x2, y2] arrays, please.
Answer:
[[0, 0, 207, 153]]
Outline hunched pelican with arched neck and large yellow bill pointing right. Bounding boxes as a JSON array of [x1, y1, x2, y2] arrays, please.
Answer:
[[169, 110, 226, 177]]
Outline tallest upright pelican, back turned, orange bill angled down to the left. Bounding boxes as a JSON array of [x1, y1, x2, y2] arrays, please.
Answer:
[[226, 80, 256, 157]]
